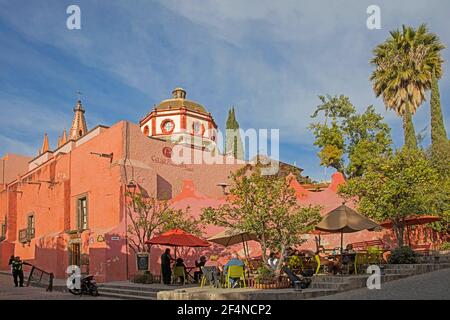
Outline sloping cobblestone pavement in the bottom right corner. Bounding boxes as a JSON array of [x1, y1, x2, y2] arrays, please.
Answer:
[[315, 269, 450, 300]]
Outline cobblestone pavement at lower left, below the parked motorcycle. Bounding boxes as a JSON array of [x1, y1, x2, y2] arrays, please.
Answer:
[[0, 274, 114, 300]]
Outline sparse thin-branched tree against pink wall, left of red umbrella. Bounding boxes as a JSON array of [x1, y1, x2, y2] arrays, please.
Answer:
[[126, 192, 202, 253]]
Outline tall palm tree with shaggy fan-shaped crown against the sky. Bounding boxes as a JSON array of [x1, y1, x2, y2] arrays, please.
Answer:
[[370, 24, 444, 148]]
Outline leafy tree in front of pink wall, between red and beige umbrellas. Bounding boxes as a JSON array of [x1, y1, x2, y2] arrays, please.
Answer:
[[202, 166, 320, 274]]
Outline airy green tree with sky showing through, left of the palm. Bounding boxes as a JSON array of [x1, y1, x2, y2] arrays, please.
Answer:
[[309, 95, 392, 177]]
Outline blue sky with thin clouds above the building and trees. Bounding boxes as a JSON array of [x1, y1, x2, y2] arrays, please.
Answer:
[[0, 0, 450, 180]]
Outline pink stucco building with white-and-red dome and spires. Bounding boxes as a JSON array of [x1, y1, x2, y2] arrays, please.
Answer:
[[0, 88, 400, 281]]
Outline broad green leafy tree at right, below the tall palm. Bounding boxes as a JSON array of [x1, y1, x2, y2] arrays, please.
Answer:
[[339, 148, 444, 247]]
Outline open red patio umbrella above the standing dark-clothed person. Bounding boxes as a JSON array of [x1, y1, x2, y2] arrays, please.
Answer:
[[145, 229, 211, 257]]
